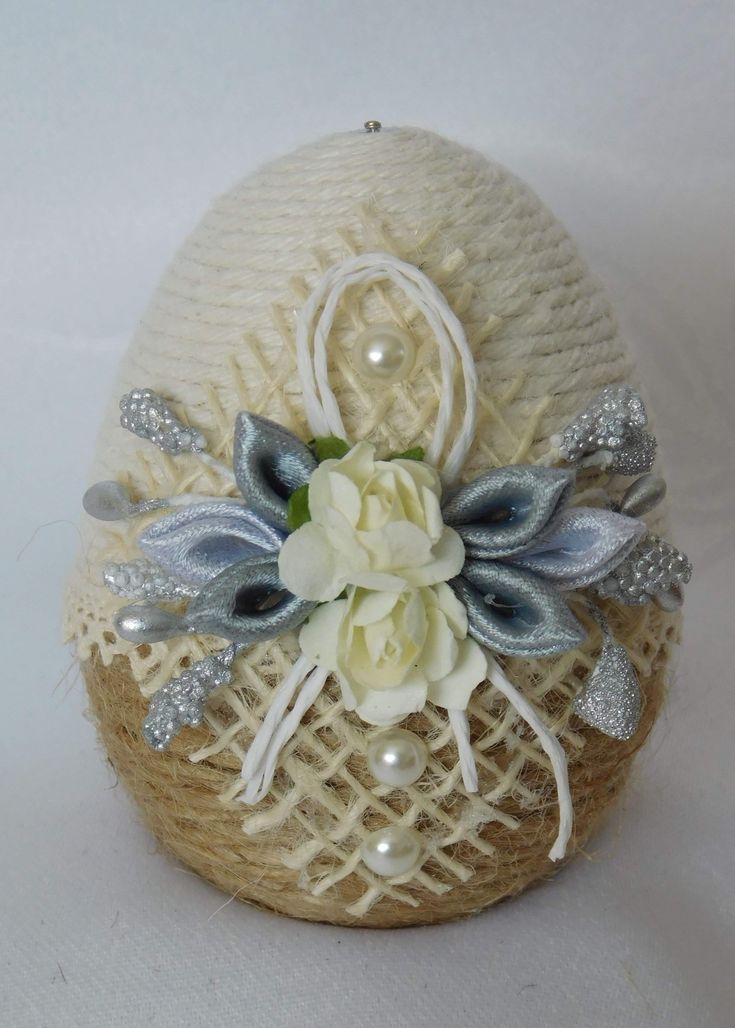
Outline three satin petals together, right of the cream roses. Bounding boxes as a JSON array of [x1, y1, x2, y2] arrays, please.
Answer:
[[442, 465, 646, 657]]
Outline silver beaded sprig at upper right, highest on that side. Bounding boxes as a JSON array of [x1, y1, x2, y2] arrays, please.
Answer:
[[551, 386, 656, 475]]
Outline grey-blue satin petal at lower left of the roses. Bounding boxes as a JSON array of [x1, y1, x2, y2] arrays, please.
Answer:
[[185, 556, 317, 646]]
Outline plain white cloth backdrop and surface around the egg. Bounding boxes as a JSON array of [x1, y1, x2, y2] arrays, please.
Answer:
[[0, 0, 735, 1028]]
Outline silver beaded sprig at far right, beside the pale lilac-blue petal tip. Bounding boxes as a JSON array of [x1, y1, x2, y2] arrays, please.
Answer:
[[594, 533, 692, 610]]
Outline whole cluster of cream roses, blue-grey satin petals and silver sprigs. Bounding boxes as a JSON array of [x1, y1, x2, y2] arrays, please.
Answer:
[[84, 378, 692, 858]]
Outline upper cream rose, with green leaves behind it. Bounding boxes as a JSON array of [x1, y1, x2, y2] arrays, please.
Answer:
[[279, 442, 465, 602]]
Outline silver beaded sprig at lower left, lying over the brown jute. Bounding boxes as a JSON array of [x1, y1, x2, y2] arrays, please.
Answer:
[[143, 643, 241, 750]]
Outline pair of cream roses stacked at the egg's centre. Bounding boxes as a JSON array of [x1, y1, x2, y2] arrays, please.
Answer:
[[279, 442, 487, 725]]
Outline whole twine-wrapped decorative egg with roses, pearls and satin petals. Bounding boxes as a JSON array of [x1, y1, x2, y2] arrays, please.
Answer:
[[67, 123, 691, 927]]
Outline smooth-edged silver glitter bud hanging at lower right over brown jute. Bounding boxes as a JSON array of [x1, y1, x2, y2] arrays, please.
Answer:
[[574, 638, 640, 739]]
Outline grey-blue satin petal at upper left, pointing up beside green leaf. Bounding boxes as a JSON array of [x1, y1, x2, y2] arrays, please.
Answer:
[[233, 412, 317, 531]]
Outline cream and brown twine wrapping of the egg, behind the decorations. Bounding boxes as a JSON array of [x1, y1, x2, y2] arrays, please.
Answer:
[[67, 130, 677, 927]]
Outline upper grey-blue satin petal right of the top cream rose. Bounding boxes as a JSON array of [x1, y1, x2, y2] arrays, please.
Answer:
[[442, 465, 575, 560]]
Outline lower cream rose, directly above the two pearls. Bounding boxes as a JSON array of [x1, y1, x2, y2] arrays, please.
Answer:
[[299, 583, 487, 725]]
